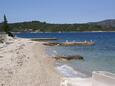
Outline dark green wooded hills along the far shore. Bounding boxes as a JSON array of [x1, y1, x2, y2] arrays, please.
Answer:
[[0, 19, 115, 32]]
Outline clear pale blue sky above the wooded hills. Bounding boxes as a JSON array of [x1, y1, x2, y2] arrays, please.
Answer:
[[0, 0, 115, 23]]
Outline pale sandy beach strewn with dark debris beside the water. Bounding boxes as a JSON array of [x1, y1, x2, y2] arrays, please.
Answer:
[[0, 38, 61, 86]]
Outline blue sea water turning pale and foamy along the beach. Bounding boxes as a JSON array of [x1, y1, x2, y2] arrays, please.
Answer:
[[16, 32, 115, 77]]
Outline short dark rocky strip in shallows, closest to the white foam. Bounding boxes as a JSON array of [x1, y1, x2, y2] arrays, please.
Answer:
[[54, 55, 84, 60]]
